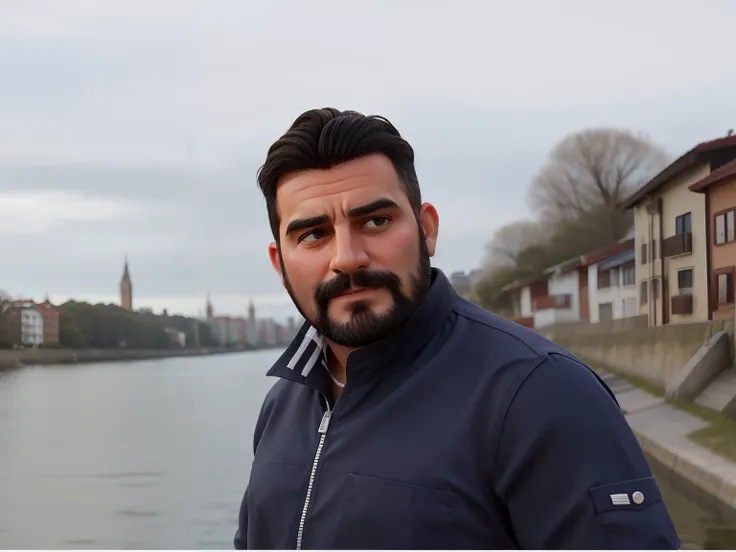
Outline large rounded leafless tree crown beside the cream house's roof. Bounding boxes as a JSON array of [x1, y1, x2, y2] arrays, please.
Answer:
[[529, 128, 670, 221]]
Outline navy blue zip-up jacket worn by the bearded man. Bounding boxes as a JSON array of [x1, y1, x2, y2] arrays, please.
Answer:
[[235, 269, 680, 549]]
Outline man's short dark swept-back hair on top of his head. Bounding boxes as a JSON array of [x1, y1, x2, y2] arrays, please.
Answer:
[[258, 107, 422, 243]]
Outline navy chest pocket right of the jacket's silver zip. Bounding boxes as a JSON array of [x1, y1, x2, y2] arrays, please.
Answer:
[[335, 474, 456, 549]]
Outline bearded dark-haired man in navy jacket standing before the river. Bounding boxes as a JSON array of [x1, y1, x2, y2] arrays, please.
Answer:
[[235, 108, 679, 549]]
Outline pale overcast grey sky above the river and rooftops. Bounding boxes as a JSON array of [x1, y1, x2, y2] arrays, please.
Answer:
[[0, 0, 736, 318]]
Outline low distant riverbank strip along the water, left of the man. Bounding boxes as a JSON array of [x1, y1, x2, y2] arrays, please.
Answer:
[[0, 347, 258, 370]]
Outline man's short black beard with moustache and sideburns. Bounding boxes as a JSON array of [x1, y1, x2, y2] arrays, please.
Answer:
[[278, 226, 432, 348]]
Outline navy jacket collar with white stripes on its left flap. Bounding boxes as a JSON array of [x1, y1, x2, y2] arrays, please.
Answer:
[[268, 268, 457, 396]]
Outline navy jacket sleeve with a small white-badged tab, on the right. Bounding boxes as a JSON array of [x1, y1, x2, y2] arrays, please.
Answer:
[[494, 354, 680, 550]]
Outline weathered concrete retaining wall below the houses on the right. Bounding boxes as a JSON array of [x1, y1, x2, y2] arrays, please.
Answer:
[[540, 315, 734, 389]]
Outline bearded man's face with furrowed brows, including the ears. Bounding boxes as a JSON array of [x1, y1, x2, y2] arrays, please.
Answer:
[[269, 154, 439, 347]]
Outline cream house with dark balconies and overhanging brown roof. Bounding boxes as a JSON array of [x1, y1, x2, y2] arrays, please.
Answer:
[[624, 135, 736, 326]]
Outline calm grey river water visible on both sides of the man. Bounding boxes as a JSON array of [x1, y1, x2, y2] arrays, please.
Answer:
[[0, 350, 736, 549]]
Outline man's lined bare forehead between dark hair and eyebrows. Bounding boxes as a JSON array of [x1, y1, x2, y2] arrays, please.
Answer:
[[276, 154, 409, 224]]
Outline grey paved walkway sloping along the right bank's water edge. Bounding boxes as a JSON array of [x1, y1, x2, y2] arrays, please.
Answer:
[[595, 368, 736, 508]]
